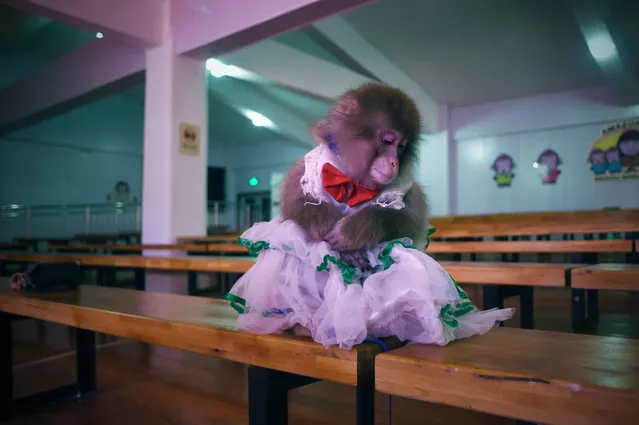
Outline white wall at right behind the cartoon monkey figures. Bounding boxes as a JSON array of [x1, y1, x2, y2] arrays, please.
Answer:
[[450, 88, 639, 214]]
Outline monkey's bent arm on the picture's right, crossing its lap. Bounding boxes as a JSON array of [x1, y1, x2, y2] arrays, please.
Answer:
[[326, 184, 428, 251]]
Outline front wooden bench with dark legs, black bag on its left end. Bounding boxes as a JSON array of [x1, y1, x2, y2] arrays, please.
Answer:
[[0, 278, 399, 425]]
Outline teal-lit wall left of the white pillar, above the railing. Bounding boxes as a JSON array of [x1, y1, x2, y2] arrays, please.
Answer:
[[0, 95, 144, 205]]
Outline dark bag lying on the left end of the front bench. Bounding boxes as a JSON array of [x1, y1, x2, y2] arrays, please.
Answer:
[[11, 261, 84, 292]]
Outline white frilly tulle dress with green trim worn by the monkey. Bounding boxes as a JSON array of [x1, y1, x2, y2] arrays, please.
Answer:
[[227, 145, 514, 349]]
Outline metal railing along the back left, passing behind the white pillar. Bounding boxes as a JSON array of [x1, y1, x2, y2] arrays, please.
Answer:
[[0, 202, 270, 241]]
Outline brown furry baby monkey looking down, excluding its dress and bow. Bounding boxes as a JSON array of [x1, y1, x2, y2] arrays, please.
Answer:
[[281, 83, 428, 268]]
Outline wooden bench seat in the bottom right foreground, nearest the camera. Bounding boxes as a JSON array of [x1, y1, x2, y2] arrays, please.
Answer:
[[375, 328, 639, 425]]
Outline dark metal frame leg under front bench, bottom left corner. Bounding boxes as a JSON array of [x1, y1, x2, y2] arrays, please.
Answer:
[[0, 312, 96, 421]]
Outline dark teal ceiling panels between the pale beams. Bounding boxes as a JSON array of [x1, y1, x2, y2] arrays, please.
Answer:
[[0, 0, 639, 147]]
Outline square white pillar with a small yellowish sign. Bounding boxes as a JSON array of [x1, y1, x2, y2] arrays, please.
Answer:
[[142, 17, 208, 247]]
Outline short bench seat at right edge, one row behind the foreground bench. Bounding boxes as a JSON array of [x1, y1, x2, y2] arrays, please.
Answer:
[[571, 264, 639, 291]]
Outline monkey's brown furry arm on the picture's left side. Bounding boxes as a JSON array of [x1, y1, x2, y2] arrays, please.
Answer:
[[281, 160, 342, 241]]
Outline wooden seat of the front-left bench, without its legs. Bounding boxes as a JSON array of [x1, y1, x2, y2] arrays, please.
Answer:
[[0, 278, 390, 385]]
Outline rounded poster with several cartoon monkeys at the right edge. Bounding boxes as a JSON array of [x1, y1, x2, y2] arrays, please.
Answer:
[[586, 121, 639, 181]]
